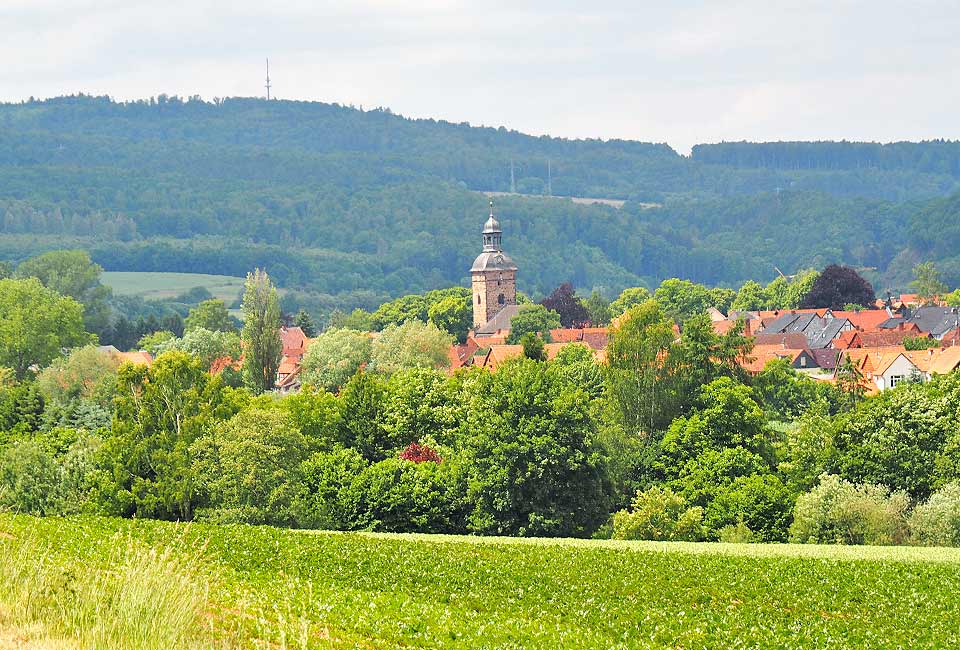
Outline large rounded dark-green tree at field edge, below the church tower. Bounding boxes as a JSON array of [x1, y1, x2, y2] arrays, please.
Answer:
[[463, 359, 610, 537]]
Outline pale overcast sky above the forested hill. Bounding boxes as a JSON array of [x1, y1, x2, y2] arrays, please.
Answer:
[[0, 0, 960, 152]]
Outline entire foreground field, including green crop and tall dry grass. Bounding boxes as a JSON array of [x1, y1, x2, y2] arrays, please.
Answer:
[[0, 515, 960, 648]]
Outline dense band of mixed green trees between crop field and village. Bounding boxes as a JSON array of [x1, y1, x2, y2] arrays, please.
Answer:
[[0, 296, 960, 545]]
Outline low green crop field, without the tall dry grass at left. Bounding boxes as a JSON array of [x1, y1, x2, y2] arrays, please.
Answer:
[[0, 515, 960, 647]]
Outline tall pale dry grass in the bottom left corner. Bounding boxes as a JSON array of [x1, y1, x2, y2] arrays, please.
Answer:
[[0, 535, 218, 650]]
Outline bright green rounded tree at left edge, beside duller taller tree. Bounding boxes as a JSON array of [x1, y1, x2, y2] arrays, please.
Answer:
[[0, 278, 93, 378]]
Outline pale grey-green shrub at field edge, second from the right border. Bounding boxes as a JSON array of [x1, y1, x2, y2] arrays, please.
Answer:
[[790, 474, 910, 545]]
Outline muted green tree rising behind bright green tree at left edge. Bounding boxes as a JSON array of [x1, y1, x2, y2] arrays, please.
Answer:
[[17, 250, 111, 334]]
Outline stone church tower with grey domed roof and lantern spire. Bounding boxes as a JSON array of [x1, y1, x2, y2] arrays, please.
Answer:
[[470, 201, 517, 330]]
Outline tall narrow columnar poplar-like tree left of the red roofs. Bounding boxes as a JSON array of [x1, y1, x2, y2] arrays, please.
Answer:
[[242, 269, 283, 395]]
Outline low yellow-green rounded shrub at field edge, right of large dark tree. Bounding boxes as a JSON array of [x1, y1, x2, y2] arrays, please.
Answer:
[[613, 487, 703, 541]]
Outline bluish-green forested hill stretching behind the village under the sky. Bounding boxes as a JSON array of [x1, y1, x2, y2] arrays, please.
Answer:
[[0, 96, 960, 311]]
